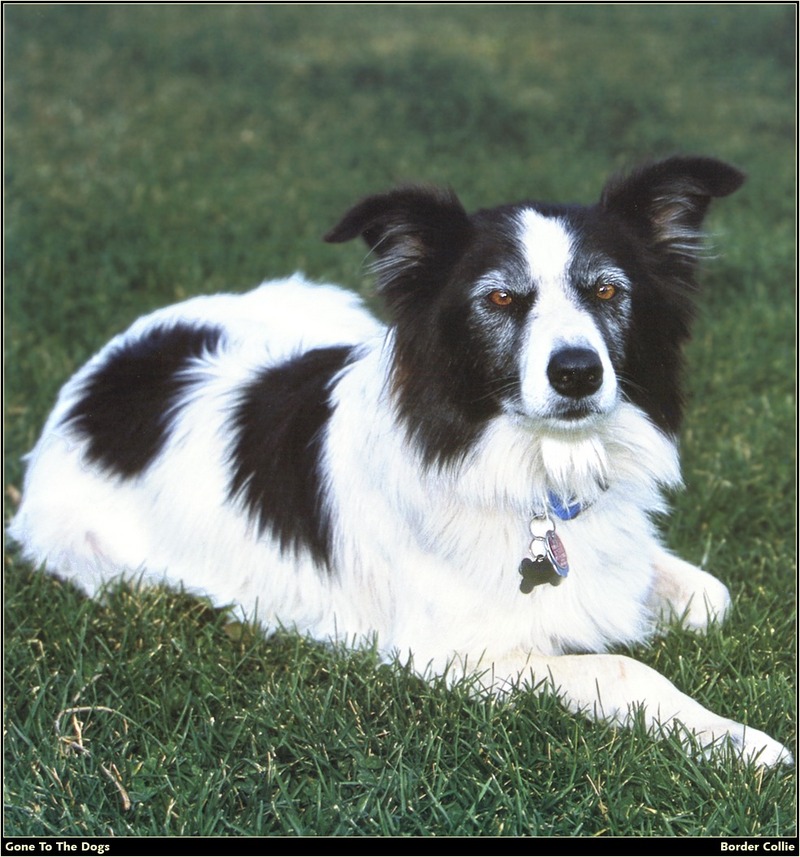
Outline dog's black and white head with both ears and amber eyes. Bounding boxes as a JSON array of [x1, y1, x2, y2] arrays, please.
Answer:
[[326, 157, 744, 461]]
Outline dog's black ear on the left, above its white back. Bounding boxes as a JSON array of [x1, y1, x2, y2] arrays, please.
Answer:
[[325, 186, 472, 280]]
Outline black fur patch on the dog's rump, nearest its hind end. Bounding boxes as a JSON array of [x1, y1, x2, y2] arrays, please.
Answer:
[[64, 323, 222, 478]]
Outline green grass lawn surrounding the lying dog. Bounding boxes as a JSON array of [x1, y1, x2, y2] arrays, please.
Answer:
[[4, 4, 796, 836]]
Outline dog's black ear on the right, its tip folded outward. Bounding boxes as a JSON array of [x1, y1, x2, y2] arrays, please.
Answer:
[[600, 157, 745, 261]]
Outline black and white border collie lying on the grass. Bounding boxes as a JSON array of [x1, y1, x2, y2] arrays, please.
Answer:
[[12, 157, 791, 765]]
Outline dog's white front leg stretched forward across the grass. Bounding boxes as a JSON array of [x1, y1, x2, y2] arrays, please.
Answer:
[[504, 655, 792, 767]]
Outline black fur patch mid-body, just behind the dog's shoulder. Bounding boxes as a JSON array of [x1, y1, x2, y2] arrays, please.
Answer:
[[230, 346, 352, 567]]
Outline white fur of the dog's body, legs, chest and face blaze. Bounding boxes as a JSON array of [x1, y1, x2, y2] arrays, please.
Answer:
[[11, 270, 790, 764]]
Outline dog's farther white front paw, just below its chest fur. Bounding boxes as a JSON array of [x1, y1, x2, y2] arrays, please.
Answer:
[[649, 551, 731, 631]]
